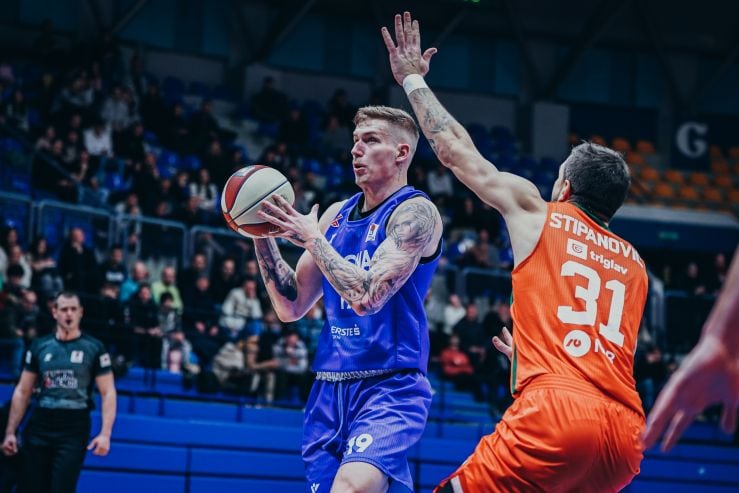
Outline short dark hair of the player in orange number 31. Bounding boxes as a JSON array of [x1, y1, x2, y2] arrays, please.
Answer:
[[564, 142, 631, 221]]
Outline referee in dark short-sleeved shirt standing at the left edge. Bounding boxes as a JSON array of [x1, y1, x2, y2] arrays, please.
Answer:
[[3, 293, 116, 493]]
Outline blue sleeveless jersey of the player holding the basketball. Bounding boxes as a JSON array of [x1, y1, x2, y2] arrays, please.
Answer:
[[313, 186, 441, 374]]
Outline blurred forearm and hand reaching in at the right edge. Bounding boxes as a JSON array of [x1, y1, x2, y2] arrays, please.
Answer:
[[644, 249, 739, 450]]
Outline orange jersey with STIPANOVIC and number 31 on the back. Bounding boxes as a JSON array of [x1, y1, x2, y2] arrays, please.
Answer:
[[511, 202, 647, 414]]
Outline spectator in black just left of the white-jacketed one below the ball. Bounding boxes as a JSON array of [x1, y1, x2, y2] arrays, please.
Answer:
[[183, 277, 224, 368]]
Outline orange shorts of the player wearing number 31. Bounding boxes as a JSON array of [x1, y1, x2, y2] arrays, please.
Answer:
[[434, 375, 644, 493]]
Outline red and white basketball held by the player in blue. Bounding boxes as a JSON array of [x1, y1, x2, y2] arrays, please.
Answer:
[[221, 164, 295, 238]]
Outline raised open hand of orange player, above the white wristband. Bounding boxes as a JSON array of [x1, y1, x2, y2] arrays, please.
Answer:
[[382, 12, 437, 85]]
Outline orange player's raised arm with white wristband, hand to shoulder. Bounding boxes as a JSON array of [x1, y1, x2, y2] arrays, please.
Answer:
[[382, 12, 545, 216]]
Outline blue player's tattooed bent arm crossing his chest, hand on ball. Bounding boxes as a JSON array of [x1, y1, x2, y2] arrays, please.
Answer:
[[260, 193, 442, 315]]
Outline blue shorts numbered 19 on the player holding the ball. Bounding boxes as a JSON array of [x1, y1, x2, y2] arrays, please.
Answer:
[[303, 371, 431, 493]]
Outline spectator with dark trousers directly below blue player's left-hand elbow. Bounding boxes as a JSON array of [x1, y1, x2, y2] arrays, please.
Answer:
[[274, 330, 308, 402]]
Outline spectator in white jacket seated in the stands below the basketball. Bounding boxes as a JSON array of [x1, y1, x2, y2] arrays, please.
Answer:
[[219, 278, 262, 341]]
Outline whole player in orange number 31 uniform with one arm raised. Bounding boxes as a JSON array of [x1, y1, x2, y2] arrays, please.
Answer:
[[382, 12, 647, 493]]
